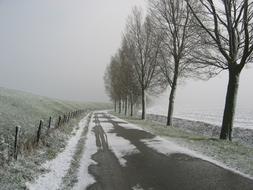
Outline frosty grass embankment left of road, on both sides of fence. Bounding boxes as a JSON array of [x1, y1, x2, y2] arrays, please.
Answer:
[[0, 88, 111, 190]]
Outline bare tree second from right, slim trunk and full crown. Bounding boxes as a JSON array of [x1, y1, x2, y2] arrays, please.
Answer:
[[149, 0, 212, 126]]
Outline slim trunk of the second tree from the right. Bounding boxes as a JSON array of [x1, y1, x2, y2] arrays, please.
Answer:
[[167, 61, 179, 126]]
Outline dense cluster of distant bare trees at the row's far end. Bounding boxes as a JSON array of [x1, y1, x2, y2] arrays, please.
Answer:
[[104, 39, 140, 116]]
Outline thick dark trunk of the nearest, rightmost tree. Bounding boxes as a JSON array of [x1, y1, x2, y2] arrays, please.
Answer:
[[220, 70, 240, 141]]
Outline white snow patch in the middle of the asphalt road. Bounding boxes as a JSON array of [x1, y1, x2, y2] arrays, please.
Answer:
[[101, 123, 139, 167]]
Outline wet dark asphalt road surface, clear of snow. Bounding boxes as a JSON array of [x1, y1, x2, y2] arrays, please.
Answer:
[[87, 113, 253, 190]]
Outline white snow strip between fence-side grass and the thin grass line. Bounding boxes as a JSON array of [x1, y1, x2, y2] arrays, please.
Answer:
[[26, 116, 87, 190]]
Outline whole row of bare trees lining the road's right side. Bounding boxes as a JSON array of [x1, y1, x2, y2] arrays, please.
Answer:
[[105, 0, 253, 140]]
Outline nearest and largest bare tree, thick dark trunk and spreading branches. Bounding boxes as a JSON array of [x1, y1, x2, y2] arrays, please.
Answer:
[[185, 0, 253, 140]]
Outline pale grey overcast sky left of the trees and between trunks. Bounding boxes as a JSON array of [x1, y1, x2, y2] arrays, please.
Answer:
[[0, 0, 253, 106]]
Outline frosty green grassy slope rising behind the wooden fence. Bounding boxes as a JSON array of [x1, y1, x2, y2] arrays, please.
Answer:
[[0, 88, 110, 142]]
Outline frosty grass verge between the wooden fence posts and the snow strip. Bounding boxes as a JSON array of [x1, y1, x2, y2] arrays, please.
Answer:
[[0, 115, 84, 190]]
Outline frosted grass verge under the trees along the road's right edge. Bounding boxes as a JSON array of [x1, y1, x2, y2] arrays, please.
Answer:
[[112, 113, 253, 177]]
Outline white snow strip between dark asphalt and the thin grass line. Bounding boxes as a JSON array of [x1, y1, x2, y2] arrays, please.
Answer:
[[73, 115, 97, 190]]
